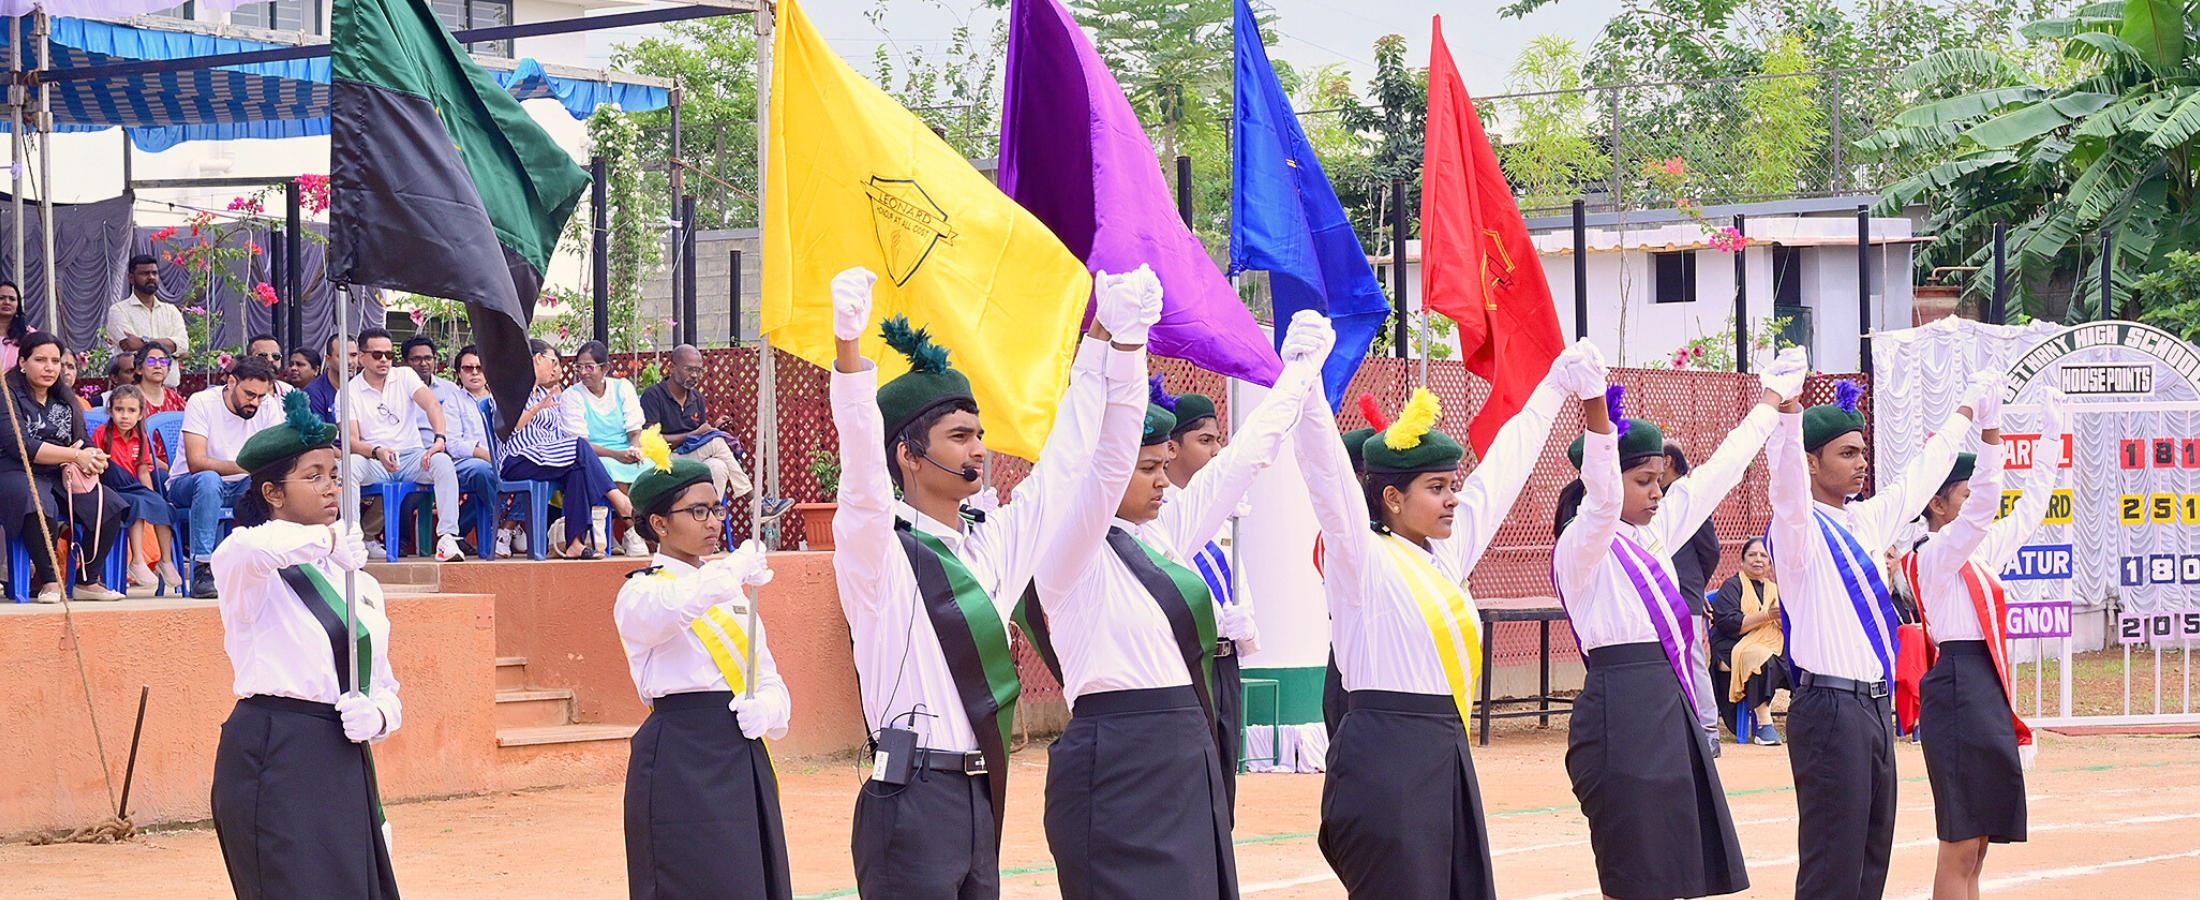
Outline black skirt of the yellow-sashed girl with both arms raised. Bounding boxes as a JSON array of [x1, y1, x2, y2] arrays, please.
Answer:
[[1320, 691, 1498, 900]]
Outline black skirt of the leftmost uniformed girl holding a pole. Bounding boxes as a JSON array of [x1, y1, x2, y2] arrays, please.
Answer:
[[213, 695, 398, 900]]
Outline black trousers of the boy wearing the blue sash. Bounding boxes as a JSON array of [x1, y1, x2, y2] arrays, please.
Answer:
[[1786, 687, 1894, 900]]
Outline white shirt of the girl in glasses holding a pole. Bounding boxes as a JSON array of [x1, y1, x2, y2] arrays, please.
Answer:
[[612, 552, 794, 739]]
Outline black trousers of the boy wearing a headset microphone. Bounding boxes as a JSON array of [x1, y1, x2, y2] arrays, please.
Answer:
[[849, 770, 1001, 900]]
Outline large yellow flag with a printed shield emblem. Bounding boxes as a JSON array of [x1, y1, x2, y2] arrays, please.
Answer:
[[763, 0, 1091, 460]]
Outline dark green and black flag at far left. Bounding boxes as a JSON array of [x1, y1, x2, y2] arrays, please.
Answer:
[[328, 0, 587, 431]]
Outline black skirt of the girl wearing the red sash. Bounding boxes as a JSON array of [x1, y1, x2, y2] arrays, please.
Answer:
[[1918, 640, 2024, 843]]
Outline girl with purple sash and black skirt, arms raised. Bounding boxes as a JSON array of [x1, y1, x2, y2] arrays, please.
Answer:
[[1551, 345, 1806, 900]]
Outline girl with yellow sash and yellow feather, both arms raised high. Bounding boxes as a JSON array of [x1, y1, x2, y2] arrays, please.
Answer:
[[1294, 345, 1604, 900]]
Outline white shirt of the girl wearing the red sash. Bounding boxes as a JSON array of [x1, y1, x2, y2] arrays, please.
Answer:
[[1918, 444, 2061, 645]]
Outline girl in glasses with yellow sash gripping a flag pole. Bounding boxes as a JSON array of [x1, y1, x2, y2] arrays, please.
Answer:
[[612, 427, 794, 900]]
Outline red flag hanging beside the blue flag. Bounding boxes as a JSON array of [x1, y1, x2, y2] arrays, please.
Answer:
[[1421, 15, 1566, 456]]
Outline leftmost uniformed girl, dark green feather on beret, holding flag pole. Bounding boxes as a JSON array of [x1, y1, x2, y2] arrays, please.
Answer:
[[211, 392, 389, 900]]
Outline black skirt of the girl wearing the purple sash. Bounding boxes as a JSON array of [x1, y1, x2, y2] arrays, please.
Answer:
[[1566, 643, 1749, 900]]
